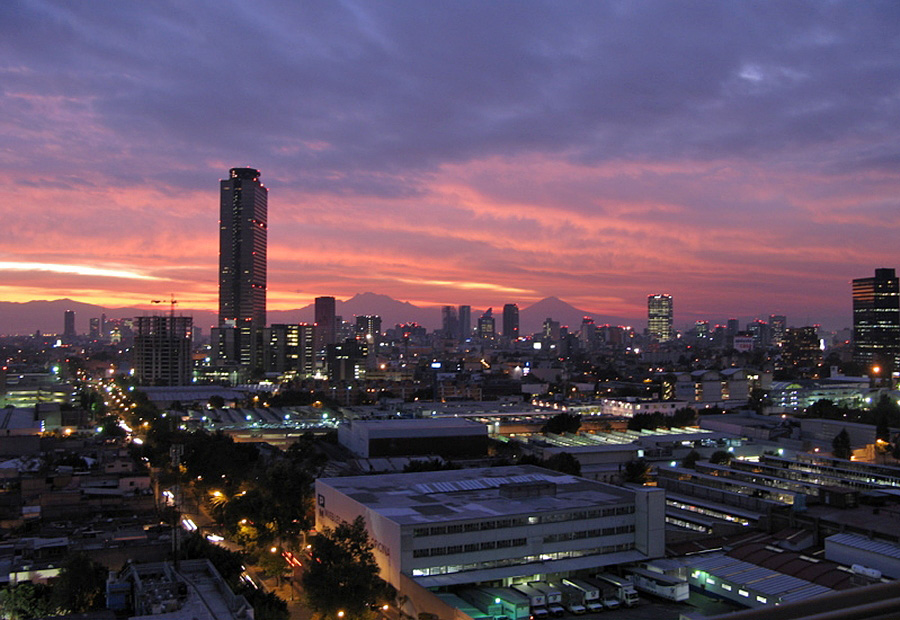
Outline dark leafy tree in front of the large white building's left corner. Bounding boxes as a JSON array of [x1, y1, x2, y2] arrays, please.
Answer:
[[302, 516, 392, 618]]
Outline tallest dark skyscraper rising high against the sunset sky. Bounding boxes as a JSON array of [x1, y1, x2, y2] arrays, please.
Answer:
[[219, 168, 269, 329]]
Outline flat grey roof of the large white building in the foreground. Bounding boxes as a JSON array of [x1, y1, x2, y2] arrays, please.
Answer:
[[318, 465, 634, 525]]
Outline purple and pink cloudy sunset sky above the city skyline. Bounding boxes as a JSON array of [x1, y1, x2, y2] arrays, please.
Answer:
[[0, 0, 900, 326]]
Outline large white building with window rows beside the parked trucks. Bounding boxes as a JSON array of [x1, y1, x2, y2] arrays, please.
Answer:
[[316, 466, 665, 589]]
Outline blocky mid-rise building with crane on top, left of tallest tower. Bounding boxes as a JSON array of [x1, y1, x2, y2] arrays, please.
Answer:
[[134, 315, 193, 386]]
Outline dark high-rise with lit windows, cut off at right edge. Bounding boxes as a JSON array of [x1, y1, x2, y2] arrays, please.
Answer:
[[853, 269, 900, 377]]
